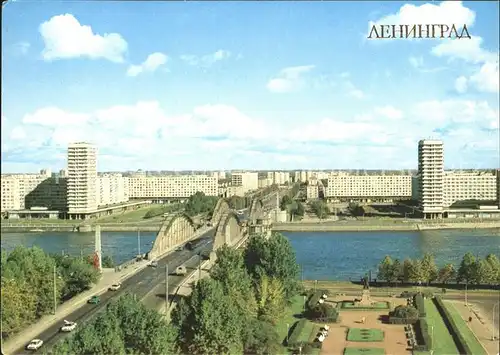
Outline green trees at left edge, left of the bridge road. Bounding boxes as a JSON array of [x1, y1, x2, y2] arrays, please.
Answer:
[[1, 246, 99, 338]]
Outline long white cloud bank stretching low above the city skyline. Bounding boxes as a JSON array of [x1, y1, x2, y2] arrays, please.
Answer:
[[2, 98, 499, 170]]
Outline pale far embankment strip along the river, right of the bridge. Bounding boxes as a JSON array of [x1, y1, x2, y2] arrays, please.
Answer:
[[273, 221, 500, 232]]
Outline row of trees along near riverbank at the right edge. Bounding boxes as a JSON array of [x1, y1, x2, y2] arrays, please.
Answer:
[[378, 252, 500, 285]]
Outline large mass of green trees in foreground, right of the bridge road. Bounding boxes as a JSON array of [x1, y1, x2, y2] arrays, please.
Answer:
[[54, 233, 300, 355]]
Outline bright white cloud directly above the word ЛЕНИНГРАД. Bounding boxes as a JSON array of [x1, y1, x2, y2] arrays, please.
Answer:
[[368, 1, 476, 38]]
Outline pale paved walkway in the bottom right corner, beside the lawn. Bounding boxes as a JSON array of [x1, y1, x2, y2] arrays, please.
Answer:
[[453, 301, 500, 355]]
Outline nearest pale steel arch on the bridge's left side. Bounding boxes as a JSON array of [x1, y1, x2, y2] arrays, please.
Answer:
[[148, 213, 197, 259]]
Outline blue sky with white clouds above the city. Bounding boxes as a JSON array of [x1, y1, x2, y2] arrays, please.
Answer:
[[1, 0, 499, 172]]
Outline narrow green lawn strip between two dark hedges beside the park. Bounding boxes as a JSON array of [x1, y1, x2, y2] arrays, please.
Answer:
[[424, 299, 458, 355]]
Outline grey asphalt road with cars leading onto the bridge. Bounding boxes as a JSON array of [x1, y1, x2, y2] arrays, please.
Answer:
[[14, 234, 214, 354]]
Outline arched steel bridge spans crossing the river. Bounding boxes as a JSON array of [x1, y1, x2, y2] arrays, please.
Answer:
[[148, 189, 287, 259]]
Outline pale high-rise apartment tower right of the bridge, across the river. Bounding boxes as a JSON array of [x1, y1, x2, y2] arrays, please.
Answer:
[[418, 139, 444, 219]]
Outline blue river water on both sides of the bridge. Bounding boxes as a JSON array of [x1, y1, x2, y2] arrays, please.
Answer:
[[1, 229, 500, 280]]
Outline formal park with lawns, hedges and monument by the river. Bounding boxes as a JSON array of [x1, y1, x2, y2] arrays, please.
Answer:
[[280, 279, 498, 355]]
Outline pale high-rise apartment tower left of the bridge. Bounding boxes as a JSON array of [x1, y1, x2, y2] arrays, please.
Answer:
[[67, 142, 98, 219]]
